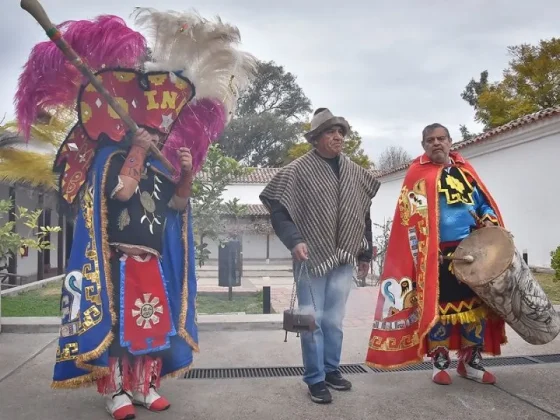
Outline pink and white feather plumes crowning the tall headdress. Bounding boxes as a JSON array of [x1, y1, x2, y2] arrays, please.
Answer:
[[15, 8, 256, 189]]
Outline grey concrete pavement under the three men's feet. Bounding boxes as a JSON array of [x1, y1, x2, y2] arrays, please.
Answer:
[[0, 328, 560, 420]]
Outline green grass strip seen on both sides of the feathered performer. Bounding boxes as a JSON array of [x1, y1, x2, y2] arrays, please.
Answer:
[[2, 282, 262, 317]]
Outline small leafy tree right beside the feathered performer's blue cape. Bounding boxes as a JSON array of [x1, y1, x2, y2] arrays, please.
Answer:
[[191, 145, 250, 266]]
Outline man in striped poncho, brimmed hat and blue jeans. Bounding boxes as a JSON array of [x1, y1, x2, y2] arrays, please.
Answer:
[[260, 108, 379, 403]]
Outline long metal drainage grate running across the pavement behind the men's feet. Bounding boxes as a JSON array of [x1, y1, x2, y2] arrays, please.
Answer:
[[184, 354, 560, 379]]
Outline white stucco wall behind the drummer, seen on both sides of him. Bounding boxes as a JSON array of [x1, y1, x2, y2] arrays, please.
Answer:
[[372, 118, 560, 267]]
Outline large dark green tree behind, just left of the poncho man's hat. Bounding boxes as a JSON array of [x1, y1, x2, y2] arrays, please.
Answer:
[[219, 61, 311, 167]]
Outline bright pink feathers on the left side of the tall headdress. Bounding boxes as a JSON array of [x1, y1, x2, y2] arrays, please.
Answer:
[[14, 15, 146, 138]]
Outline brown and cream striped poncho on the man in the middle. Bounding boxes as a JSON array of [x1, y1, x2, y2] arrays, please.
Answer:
[[259, 150, 380, 276]]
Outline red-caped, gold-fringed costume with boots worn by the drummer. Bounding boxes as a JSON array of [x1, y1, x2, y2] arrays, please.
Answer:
[[366, 152, 506, 384]]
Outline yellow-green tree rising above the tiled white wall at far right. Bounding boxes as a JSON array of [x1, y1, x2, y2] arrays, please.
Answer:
[[461, 38, 560, 130]]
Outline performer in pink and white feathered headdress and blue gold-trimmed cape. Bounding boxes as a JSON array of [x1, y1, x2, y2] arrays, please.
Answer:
[[16, 9, 255, 419]]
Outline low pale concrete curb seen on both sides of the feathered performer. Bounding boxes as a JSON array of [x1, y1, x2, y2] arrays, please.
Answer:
[[2, 314, 283, 334]]
